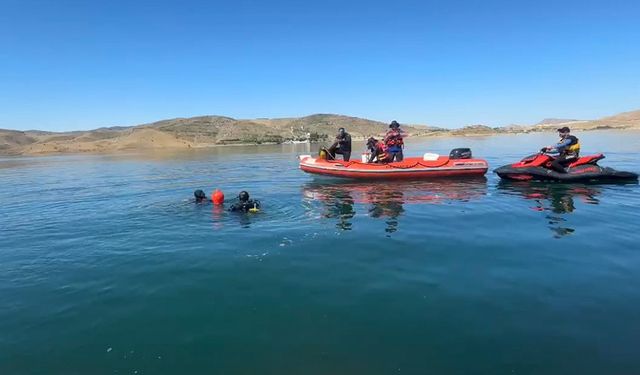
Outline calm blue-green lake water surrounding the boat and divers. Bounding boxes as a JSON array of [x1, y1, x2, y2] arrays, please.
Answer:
[[0, 132, 640, 375]]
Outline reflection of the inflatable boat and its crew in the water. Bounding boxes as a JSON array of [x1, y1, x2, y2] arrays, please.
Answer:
[[302, 177, 487, 234]]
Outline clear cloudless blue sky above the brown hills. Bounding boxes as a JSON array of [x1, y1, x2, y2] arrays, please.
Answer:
[[0, 0, 640, 130]]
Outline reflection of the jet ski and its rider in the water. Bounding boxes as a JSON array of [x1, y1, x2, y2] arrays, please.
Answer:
[[498, 181, 602, 238]]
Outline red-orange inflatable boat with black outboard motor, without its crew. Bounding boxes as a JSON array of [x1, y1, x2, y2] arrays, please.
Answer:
[[299, 149, 489, 180]]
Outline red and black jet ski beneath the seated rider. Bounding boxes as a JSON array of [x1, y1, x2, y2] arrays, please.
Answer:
[[494, 152, 638, 182]]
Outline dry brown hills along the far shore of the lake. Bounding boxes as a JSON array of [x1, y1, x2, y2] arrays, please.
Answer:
[[0, 111, 640, 155]]
